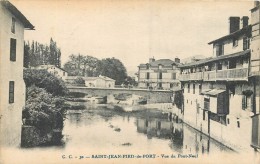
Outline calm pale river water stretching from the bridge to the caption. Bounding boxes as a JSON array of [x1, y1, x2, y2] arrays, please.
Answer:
[[1, 104, 240, 163]]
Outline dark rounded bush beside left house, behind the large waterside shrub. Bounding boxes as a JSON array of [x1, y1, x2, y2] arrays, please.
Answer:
[[24, 69, 68, 96]]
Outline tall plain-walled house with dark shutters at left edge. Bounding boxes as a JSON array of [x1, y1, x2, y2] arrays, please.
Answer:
[[0, 0, 34, 146]]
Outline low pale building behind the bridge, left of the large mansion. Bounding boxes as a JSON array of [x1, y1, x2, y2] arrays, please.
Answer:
[[65, 75, 115, 88]]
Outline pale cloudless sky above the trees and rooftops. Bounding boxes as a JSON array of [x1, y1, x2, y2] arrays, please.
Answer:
[[10, 0, 253, 74]]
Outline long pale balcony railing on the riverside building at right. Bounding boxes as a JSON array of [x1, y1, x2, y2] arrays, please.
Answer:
[[180, 68, 248, 81]]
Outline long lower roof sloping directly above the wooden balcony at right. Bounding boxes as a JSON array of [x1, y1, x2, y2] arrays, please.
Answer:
[[179, 49, 250, 68]]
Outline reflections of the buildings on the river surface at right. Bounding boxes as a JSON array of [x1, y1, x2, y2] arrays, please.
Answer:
[[137, 118, 231, 154]]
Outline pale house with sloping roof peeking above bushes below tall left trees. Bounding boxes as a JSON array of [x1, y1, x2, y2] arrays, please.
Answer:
[[35, 65, 68, 80]]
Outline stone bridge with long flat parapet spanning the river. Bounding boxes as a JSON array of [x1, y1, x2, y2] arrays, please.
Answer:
[[67, 86, 177, 104]]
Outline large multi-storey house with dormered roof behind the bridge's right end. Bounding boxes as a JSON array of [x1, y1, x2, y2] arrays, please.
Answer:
[[138, 58, 180, 89]]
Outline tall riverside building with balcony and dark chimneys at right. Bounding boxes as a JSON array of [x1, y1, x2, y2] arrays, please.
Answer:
[[179, 2, 260, 150]]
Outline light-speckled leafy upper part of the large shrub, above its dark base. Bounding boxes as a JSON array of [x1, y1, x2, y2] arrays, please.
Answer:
[[23, 85, 65, 133]]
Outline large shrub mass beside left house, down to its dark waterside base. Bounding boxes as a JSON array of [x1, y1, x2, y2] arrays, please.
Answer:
[[22, 85, 66, 147]]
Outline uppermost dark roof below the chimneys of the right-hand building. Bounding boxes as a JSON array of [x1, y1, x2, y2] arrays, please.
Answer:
[[208, 25, 251, 44]]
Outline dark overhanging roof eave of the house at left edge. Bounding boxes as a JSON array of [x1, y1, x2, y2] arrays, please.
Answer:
[[0, 0, 34, 30]]
